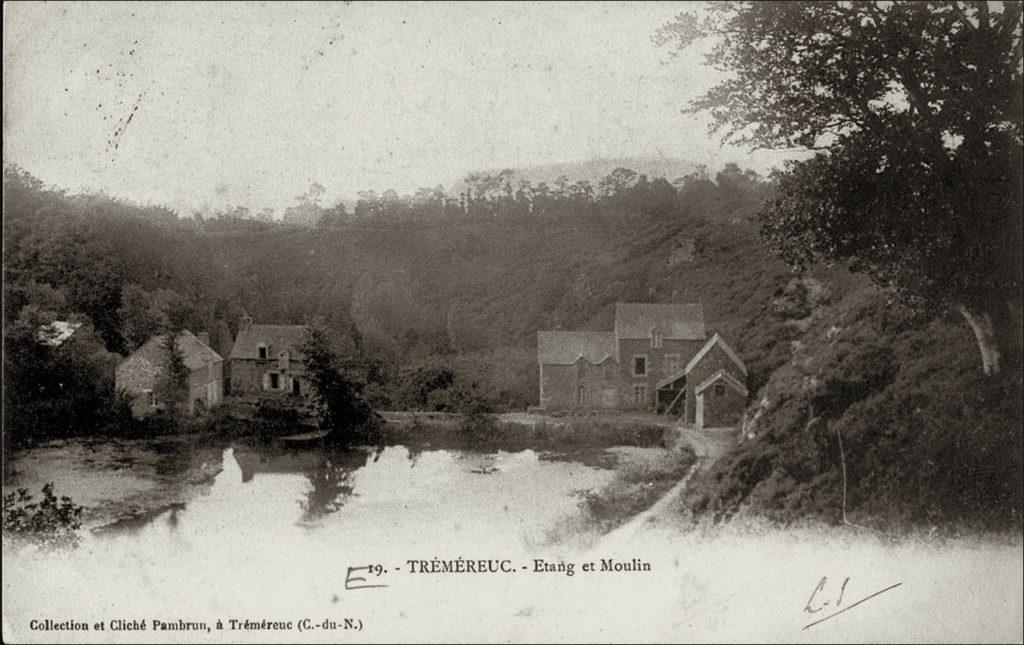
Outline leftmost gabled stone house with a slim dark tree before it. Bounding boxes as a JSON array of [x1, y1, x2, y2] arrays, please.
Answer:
[[114, 331, 224, 419]]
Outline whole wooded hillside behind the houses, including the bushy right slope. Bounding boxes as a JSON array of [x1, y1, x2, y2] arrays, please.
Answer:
[[4, 163, 1024, 529]]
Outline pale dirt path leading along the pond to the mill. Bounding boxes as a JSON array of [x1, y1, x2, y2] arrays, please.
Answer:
[[592, 426, 736, 552]]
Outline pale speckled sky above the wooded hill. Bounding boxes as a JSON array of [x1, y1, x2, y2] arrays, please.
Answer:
[[3, 2, 798, 216]]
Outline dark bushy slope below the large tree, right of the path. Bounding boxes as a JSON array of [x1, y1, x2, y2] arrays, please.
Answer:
[[686, 286, 1024, 532]]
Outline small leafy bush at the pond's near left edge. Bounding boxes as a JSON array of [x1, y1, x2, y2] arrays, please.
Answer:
[[3, 483, 82, 549]]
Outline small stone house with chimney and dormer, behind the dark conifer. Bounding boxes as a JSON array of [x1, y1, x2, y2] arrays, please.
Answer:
[[231, 316, 309, 396]]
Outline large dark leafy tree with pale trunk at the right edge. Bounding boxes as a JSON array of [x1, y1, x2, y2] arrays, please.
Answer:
[[655, 2, 1024, 374]]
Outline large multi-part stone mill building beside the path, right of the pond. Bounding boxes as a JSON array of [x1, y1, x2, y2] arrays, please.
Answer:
[[537, 303, 748, 427]]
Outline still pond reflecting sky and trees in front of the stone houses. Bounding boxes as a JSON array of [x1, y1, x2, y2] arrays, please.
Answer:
[[4, 439, 622, 546]]
